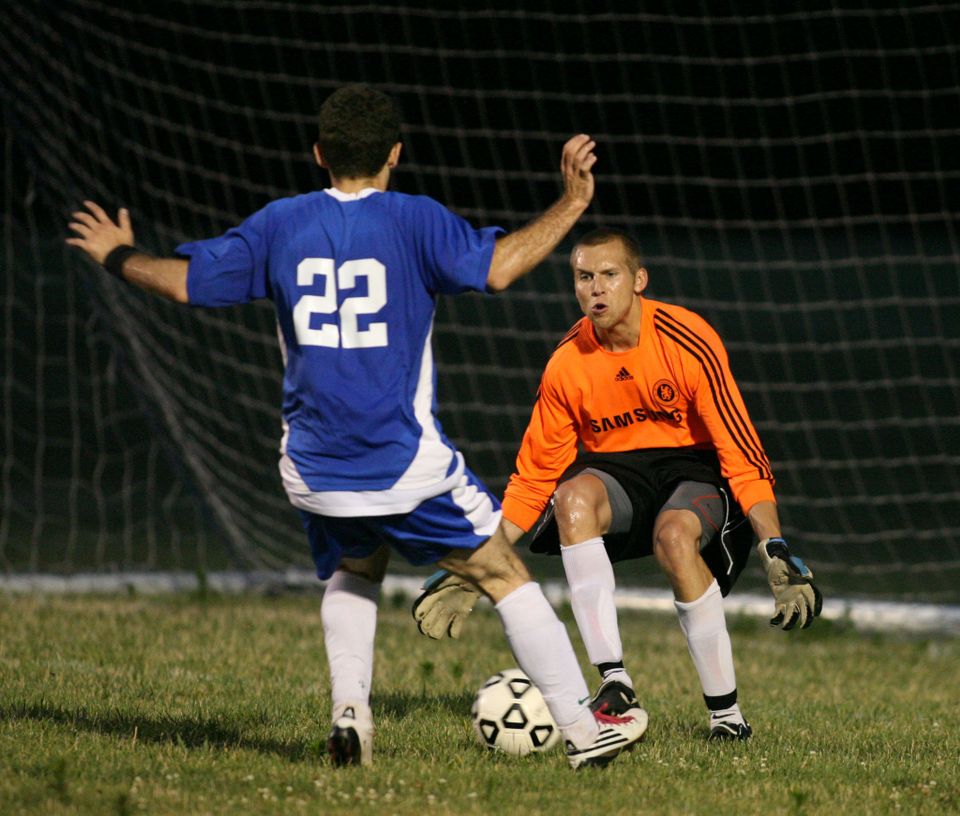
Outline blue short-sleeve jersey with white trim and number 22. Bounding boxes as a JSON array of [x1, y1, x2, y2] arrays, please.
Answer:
[[177, 190, 501, 516]]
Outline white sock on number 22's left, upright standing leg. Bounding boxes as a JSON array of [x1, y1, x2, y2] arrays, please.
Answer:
[[320, 570, 380, 714]]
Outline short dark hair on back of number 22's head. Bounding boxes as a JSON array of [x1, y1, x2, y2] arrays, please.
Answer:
[[317, 85, 400, 178]]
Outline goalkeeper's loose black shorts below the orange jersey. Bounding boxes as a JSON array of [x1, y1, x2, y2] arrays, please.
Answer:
[[530, 448, 753, 595]]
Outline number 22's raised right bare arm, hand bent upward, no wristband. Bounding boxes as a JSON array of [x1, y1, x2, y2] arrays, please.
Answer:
[[487, 133, 597, 292]]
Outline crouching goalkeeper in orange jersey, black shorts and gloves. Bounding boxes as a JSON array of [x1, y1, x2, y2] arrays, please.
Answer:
[[414, 229, 822, 740]]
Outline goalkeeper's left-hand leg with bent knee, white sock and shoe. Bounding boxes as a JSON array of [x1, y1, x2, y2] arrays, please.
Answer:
[[554, 468, 638, 713]]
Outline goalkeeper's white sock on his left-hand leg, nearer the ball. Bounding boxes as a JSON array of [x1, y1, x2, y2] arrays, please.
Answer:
[[560, 537, 623, 665]]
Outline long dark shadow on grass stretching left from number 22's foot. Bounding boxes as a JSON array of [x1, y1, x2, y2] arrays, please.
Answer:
[[0, 701, 319, 762]]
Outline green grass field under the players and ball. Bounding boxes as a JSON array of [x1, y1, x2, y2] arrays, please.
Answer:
[[0, 594, 960, 816]]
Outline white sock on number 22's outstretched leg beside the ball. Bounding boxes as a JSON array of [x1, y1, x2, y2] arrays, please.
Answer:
[[495, 581, 599, 748]]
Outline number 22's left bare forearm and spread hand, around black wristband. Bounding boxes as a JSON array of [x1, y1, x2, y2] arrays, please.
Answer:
[[67, 201, 188, 303]]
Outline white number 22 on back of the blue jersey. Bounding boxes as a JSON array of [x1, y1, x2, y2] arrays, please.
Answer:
[[293, 258, 387, 348]]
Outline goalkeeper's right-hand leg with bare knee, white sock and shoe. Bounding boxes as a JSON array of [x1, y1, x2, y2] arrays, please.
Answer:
[[653, 482, 750, 739]]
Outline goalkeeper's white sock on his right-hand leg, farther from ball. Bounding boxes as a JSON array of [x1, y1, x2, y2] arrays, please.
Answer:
[[673, 580, 737, 697]]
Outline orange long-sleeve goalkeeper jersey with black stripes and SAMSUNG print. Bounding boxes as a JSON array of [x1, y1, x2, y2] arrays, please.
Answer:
[[503, 298, 774, 530]]
